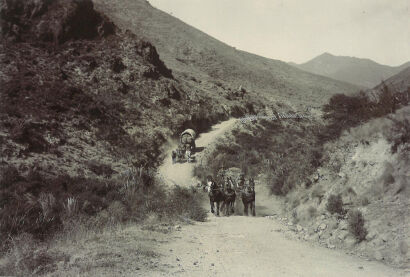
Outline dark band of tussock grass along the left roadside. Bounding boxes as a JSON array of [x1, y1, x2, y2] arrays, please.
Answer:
[[0, 167, 206, 251]]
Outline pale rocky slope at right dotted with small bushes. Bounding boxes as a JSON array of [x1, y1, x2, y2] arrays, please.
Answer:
[[283, 107, 410, 268]]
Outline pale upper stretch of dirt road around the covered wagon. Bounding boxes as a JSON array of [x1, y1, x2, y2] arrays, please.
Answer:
[[158, 119, 237, 186]]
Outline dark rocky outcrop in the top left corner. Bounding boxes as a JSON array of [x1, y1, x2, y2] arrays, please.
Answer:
[[0, 0, 115, 44]]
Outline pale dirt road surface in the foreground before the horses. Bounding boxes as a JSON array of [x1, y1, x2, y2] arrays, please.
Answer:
[[147, 215, 408, 277]]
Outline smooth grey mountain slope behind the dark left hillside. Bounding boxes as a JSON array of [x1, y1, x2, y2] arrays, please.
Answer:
[[94, 0, 357, 105]]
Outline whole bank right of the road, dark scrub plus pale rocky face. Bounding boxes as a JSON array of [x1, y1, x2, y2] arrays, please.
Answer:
[[196, 86, 410, 266]]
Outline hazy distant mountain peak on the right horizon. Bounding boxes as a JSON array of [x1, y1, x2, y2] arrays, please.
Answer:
[[291, 53, 410, 88]]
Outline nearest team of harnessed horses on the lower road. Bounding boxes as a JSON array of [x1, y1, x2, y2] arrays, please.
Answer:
[[206, 174, 256, 216]]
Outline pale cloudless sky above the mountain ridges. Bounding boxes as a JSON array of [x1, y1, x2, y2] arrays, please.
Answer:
[[149, 0, 410, 66]]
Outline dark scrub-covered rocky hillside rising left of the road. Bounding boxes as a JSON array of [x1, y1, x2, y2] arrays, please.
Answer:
[[0, 0, 270, 248]]
